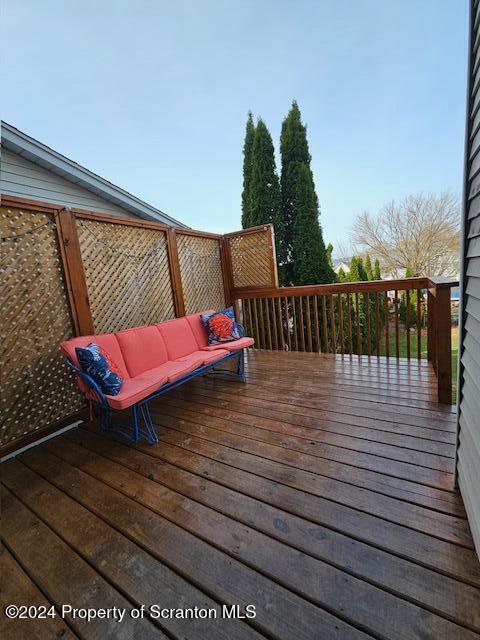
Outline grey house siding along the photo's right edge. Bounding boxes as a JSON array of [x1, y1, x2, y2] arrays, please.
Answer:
[[457, 0, 480, 554]]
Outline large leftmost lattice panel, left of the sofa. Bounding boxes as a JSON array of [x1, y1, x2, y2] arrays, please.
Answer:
[[0, 207, 82, 445]]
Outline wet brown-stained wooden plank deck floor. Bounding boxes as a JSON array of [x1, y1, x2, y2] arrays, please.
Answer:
[[1, 352, 480, 640]]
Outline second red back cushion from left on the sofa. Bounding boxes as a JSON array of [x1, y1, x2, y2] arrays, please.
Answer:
[[115, 326, 168, 378]]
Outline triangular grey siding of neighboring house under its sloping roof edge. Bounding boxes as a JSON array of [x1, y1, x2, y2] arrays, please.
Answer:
[[0, 149, 132, 216]]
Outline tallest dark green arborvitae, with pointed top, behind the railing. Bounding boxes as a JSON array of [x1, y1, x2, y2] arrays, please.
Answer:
[[280, 101, 335, 285]]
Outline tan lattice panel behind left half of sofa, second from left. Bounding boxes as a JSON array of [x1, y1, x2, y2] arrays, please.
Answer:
[[77, 218, 175, 333]]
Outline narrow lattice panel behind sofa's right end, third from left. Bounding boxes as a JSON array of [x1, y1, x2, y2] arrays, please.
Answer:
[[177, 234, 225, 314]]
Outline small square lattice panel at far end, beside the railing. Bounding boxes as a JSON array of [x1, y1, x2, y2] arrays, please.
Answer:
[[228, 229, 275, 288]]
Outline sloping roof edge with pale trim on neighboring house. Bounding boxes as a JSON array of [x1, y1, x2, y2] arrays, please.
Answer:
[[1, 121, 187, 227]]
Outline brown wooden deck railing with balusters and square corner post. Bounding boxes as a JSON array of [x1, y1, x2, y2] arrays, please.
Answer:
[[232, 278, 458, 404]]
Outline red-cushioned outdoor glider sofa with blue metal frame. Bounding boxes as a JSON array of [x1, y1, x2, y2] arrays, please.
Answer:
[[60, 311, 254, 443]]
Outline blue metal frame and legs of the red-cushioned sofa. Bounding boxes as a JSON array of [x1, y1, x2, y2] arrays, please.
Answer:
[[66, 349, 245, 444]]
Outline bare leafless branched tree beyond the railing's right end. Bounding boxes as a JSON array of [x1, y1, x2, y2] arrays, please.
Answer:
[[351, 191, 460, 277]]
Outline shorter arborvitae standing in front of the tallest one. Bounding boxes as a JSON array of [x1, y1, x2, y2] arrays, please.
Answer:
[[291, 163, 334, 285]]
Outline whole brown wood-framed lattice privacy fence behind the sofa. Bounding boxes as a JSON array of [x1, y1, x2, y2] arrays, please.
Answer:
[[0, 197, 277, 453]]
